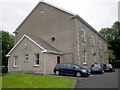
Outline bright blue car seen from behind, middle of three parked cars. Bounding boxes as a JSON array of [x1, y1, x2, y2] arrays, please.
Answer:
[[90, 64, 104, 74]]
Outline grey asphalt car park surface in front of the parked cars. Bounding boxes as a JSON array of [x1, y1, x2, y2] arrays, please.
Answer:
[[75, 69, 118, 88]]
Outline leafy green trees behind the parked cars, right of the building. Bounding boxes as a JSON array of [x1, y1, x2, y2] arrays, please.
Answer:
[[99, 21, 120, 64]]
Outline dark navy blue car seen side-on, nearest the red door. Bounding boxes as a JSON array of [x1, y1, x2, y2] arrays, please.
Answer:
[[53, 63, 90, 77]]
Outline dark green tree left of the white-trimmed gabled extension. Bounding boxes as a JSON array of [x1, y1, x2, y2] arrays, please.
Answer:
[[0, 30, 14, 66]]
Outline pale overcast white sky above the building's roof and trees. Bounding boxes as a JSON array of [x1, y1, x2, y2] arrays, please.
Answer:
[[0, 0, 120, 33]]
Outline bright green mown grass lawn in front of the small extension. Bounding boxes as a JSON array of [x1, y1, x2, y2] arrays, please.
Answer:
[[2, 73, 75, 88]]
